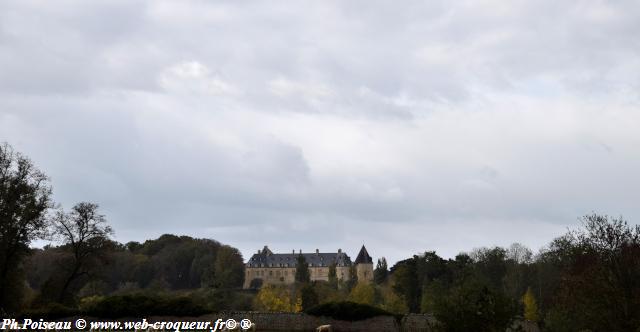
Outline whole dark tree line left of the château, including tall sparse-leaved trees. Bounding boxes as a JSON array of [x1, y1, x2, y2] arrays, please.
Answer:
[[0, 143, 244, 313]]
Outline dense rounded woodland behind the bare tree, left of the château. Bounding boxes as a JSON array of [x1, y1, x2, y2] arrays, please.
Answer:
[[25, 235, 244, 302]]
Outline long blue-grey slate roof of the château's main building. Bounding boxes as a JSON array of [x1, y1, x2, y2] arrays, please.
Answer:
[[247, 246, 351, 267]]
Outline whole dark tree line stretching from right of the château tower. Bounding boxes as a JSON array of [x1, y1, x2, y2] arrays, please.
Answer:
[[376, 214, 640, 331]]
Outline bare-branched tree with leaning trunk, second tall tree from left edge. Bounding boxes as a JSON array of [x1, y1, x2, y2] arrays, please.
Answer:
[[54, 202, 113, 302]]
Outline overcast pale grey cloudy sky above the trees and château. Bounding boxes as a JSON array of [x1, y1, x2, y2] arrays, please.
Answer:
[[0, 0, 640, 264]]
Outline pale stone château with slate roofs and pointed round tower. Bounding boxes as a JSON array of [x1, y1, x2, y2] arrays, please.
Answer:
[[243, 246, 373, 289]]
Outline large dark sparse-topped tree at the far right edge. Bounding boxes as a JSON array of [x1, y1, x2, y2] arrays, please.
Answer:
[[548, 214, 640, 331]]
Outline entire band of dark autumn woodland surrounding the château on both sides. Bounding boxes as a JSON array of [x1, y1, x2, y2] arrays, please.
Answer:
[[0, 144, 640, 331]]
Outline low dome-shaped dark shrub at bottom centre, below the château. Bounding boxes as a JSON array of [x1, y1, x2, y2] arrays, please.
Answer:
[[306, 301, 397, 321]]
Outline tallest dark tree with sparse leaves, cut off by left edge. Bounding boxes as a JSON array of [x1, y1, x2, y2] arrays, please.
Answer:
[[0, 143, 51, 312]]
